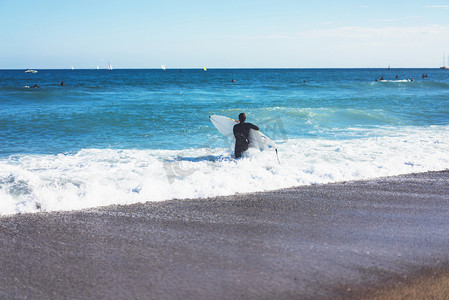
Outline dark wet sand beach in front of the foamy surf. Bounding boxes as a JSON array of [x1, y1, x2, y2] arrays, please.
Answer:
[[0, 171, 449, 299]]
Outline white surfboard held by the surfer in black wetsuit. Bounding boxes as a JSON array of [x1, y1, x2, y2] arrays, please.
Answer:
[[209, 115, 277, 151]]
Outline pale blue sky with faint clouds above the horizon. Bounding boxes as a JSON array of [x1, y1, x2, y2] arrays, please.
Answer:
[[0, 0, 449, 69]]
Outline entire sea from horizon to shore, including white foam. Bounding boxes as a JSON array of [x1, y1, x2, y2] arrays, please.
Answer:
[[0, 69, 449, 215]]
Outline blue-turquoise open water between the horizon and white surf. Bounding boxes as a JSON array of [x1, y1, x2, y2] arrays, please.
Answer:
[[0, 69, 449, 156]]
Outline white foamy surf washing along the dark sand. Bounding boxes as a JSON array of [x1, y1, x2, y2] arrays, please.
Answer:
[[0, 126, 449, 215]]
